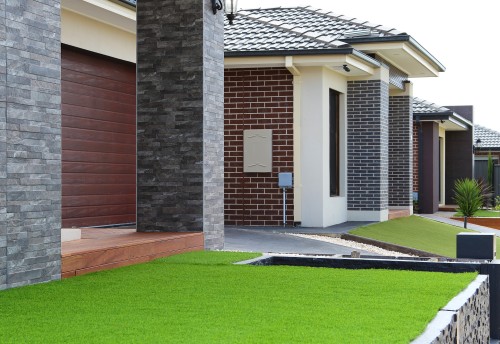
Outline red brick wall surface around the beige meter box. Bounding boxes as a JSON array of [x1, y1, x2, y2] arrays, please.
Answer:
[[224, 68, 293, 226]]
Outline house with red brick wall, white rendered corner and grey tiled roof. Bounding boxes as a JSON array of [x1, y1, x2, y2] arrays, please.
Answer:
[[225, 7, 444, 227]]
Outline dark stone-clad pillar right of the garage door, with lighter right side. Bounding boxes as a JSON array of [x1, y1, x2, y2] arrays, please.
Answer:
[[137, 0, 224, 249]]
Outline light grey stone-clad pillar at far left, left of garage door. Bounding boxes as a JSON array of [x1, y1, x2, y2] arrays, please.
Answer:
[[0, 0, 61, 289]]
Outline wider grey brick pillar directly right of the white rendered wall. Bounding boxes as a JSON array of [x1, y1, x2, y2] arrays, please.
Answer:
[[347, 80, 389, 211]]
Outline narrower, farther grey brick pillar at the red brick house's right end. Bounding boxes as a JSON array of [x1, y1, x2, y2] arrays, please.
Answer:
[[389, 96, 413, 207]]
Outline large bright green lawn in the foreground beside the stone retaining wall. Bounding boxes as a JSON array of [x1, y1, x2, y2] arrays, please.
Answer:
[[0, 252, 476, 343]]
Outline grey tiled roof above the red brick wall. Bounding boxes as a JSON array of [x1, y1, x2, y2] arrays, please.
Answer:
[[224, 7, 406, 52]]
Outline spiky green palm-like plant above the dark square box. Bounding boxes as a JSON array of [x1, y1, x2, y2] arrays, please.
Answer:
[[453, 178, 483, 228]]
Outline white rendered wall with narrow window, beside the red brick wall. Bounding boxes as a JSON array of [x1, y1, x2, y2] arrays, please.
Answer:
[[300, 67, 347, 227]]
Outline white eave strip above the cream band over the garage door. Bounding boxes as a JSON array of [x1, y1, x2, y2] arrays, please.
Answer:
[[61, 0, 137, 34]]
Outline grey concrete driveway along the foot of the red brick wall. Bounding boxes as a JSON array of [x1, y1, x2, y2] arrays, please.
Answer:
[[224, 223, 375, 255]]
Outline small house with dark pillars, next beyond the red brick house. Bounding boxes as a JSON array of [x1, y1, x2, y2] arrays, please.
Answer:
[[413, 98, 473, 213]]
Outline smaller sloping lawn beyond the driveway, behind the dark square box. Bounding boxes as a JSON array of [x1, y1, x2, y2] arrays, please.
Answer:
[[349, 215, 500, 258]]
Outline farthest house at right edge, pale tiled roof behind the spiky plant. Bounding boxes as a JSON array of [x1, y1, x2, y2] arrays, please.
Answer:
[[474, 125, 500, 196]]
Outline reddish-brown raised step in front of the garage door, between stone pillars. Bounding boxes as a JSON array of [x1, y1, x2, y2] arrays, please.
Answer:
[[62, 228, 203, 278]]
